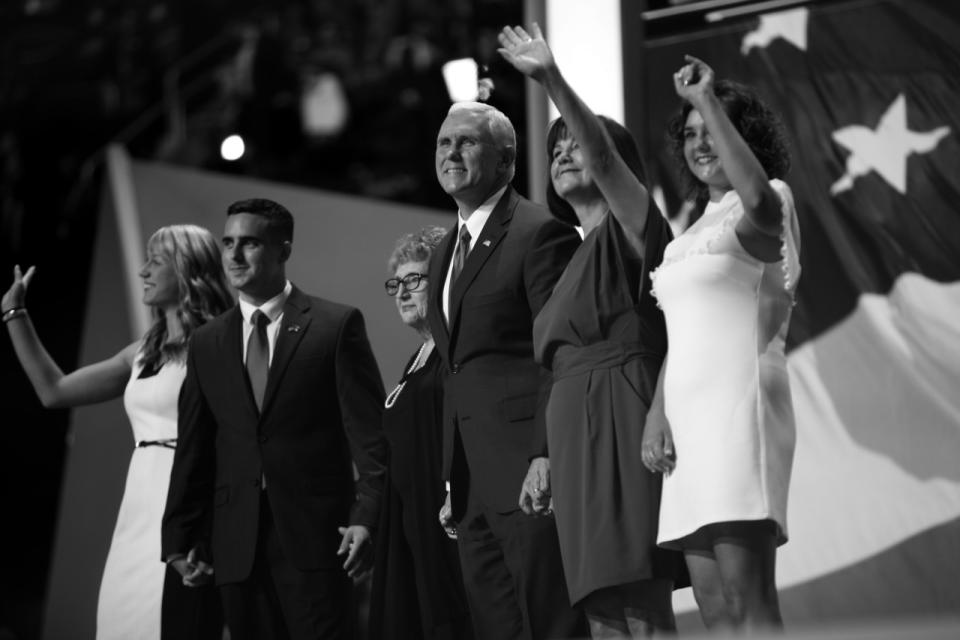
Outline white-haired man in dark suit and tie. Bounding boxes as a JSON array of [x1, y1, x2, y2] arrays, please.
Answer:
[[428, 103, 587, 640]]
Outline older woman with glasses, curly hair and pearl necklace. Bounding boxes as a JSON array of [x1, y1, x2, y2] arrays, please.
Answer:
[[370, 227, 472, 640]]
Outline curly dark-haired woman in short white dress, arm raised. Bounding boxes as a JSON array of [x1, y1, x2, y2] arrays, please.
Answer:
[[642, 56, 800, 629]]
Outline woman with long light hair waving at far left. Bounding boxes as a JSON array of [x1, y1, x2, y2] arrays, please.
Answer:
[[0, 225, 233, 640]]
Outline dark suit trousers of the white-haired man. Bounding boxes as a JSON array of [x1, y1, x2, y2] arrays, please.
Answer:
[[457, 487, 588, 640]]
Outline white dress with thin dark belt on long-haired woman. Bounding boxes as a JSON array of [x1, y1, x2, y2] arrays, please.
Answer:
[[97, 353, 187, 640]]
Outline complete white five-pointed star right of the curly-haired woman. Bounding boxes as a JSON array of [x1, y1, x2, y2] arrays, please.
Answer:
[[830, 93, 950, 195]]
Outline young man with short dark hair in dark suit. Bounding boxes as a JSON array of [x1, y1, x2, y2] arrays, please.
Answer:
[[162, 199, 386, 640]]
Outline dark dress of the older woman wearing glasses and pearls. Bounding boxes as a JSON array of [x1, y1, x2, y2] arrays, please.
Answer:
[[369, 350, 472, 640]]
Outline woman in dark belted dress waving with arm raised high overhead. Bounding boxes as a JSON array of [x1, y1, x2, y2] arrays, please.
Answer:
[[500, 25, 683, 638]]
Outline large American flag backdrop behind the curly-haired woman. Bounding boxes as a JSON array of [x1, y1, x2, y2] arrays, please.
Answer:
[[627, 0, 960, 623]]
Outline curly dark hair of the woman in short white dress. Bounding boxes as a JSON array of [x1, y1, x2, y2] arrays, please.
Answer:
[[667, 80, 790, 202]]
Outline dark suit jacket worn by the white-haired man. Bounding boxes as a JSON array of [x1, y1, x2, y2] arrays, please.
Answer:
[[428, 187, 580, 518]]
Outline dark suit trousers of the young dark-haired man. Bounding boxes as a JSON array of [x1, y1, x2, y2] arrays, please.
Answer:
[[214, 492, 353, 640]]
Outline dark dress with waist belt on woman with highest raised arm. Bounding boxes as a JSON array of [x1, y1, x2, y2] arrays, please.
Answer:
[[533, 205, 683, 603]]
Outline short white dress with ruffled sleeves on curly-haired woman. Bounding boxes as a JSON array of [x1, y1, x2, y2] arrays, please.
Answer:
[[651, 180, 800, 547]]
